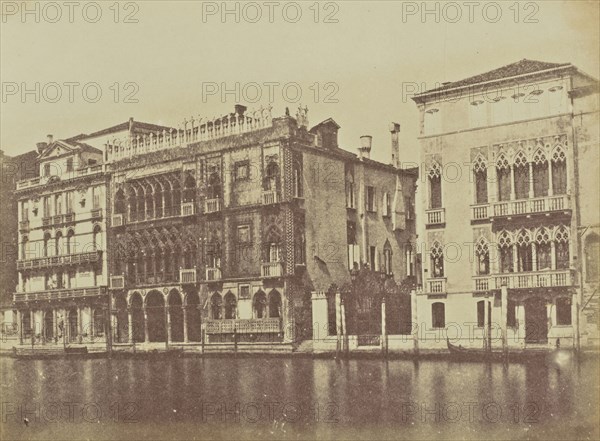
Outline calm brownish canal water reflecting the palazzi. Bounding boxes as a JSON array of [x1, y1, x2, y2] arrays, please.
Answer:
[[0, 353, 599, 440]]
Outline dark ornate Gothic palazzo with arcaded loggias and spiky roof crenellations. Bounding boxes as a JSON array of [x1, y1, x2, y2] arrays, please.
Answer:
[[106, 106, 416, 350]]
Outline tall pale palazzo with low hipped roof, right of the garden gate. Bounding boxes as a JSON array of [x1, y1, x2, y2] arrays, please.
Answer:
[[413, 60, 599, 346]]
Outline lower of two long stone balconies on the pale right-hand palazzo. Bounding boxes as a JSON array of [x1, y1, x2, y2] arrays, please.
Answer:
[[473, 269, 575, 291]]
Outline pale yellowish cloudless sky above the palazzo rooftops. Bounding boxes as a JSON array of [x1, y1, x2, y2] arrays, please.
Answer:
[[0, 1, 600, 162]]
